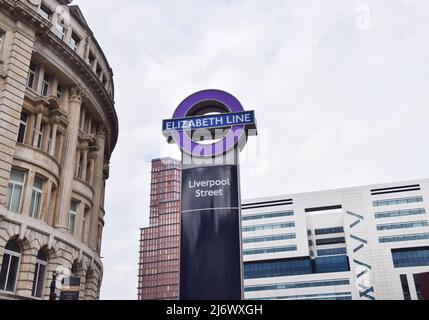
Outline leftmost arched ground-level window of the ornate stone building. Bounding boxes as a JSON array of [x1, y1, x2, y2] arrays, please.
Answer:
[[0, 240, 21, 292]]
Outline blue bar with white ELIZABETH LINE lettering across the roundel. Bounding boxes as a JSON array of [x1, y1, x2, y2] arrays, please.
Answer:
[[162, 111, 256, 134]]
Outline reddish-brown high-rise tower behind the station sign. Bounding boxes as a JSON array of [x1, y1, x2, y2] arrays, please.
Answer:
[[138, 158, 181, 300]]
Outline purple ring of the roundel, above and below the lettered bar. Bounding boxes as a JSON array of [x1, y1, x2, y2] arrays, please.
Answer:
[[173, 89, 245, 158]]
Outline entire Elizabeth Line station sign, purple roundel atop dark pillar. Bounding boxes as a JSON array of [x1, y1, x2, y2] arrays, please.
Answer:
[[163, 90, 256, 300]]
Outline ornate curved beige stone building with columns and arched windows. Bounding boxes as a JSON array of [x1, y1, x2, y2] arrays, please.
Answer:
[[0, 0, 118, 299]]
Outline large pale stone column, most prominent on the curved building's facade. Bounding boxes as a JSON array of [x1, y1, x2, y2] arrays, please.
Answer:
[[55, 87, 86, 232]]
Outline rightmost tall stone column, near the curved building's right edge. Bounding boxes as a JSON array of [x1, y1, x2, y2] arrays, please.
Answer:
[[88, 127, 106, 251]]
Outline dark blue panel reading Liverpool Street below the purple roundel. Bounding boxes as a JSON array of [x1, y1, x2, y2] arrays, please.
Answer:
[[180, 165, 242, 300]]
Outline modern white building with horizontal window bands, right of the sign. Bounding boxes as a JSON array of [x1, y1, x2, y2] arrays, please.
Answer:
[[242, 179, 429, 300]]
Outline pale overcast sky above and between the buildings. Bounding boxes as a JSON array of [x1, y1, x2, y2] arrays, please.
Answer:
[[74, 0, 429, 299]]
